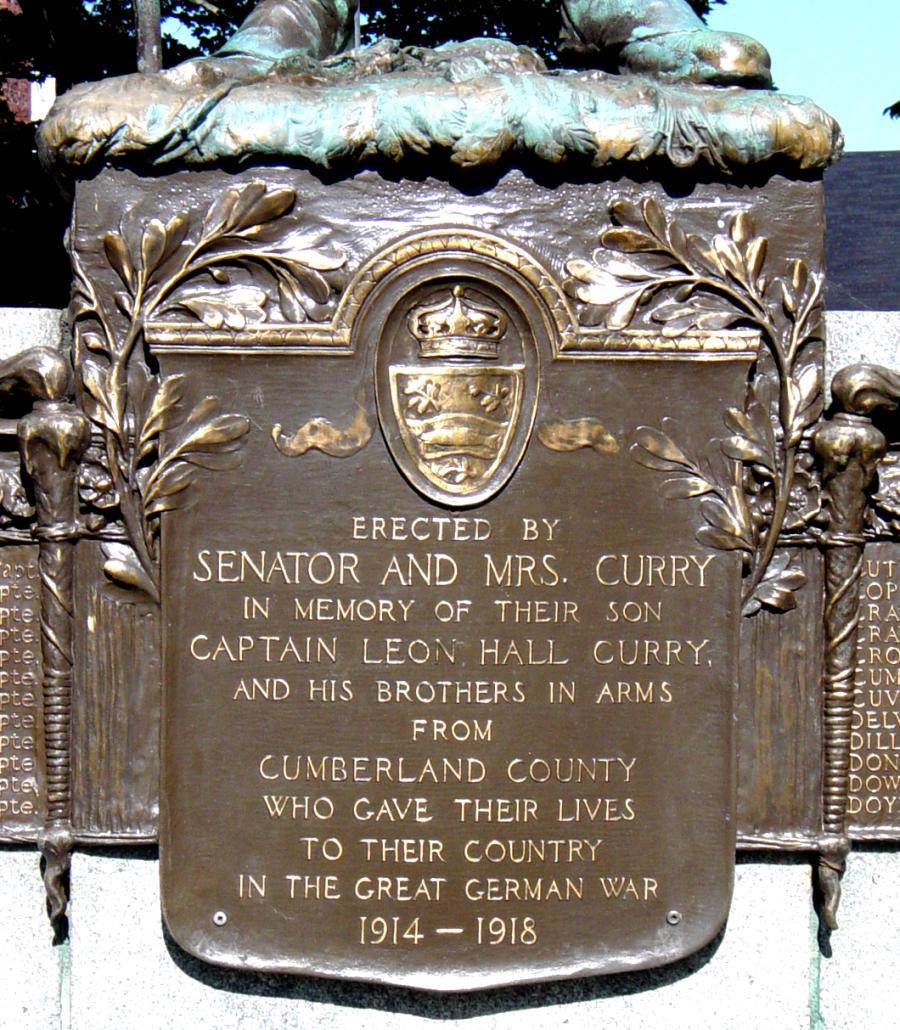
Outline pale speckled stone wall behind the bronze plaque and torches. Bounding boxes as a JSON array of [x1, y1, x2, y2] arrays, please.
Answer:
[[0, 310, 900, 1030]]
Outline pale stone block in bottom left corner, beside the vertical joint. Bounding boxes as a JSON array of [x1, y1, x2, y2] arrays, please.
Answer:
[[0, 848, 67, 1030]]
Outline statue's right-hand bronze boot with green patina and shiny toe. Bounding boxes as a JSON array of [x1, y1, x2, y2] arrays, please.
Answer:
[[562, 0, 772, 89]]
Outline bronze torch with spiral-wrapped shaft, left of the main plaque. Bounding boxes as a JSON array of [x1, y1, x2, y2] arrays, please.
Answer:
[[0, 347, 91, 938]]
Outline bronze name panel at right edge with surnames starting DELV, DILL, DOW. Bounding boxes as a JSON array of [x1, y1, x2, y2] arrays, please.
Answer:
[[847, 543, 900, 839]]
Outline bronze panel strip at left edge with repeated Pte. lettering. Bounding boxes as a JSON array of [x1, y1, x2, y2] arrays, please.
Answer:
[[0, 544, 43, 839]]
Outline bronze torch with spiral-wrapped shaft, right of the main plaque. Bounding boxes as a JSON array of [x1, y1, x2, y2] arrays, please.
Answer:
[[815, 365, 900, 930]]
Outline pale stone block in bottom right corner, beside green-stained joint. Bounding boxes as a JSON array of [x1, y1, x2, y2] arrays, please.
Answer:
[[814, 850, 900, 1030]]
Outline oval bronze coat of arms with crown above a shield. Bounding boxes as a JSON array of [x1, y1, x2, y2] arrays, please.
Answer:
[[376, 281, 538, 508]]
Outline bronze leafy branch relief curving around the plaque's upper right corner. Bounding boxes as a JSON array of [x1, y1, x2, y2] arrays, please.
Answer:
[[580, 198, 823, 615]]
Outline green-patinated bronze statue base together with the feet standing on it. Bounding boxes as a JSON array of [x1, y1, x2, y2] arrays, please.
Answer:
[[39, 0, 842, 173]]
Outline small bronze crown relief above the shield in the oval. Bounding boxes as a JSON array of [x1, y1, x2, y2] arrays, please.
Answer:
[[408, 285, 509, 358]]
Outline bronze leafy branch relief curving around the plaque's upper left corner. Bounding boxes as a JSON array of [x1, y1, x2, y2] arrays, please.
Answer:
[[70, 181, 325, 602]]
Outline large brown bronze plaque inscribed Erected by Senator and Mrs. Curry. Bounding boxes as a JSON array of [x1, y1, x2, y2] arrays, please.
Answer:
[[161, 243, 749, 990]]
